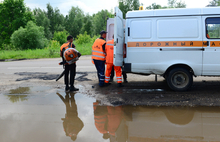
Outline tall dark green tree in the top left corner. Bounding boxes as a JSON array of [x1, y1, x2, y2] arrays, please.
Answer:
[[0, 0, 34, 46]]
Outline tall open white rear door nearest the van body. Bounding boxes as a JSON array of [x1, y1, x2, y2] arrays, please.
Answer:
[[114, 7, 124, 66]]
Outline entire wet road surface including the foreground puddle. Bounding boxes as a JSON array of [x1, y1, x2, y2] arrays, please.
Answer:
[[0, 56, 220, 142]]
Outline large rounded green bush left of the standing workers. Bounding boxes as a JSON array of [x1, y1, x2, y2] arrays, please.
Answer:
[[11, 21, 46, 49]]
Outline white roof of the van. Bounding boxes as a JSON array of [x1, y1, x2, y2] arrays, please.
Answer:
[[126, 7, 220, 19]]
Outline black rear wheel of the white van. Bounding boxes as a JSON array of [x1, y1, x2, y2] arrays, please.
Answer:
[[166, 68, 193, 91]]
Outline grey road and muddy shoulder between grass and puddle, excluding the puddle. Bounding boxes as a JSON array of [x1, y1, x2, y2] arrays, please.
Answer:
[[0, 56, 220, 106]]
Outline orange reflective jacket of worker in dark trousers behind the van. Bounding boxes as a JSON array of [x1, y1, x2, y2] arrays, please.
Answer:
[[92, 38, 105, 61]]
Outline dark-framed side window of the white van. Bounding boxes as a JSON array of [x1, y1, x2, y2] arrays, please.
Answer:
[[206, 18, 220, 38]]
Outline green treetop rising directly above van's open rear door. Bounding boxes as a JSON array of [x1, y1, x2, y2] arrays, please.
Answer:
[[118, 0, 140, 18]]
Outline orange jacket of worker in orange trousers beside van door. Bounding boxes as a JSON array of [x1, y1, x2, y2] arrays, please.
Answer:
[[105, 39, 114, 64]]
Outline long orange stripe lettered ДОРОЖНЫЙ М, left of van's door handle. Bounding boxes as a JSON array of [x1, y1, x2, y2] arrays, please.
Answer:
[[127, 41, 207, 47]]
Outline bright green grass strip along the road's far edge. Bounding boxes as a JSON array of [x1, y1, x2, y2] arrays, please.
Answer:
[[0, 42, 92, 60]]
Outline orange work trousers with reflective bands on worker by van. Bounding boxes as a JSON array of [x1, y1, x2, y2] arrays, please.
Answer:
[[105, 63, 122, 83]]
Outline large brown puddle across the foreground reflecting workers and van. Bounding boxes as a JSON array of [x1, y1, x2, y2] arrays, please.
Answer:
[[0, 86, 220, 142]]
